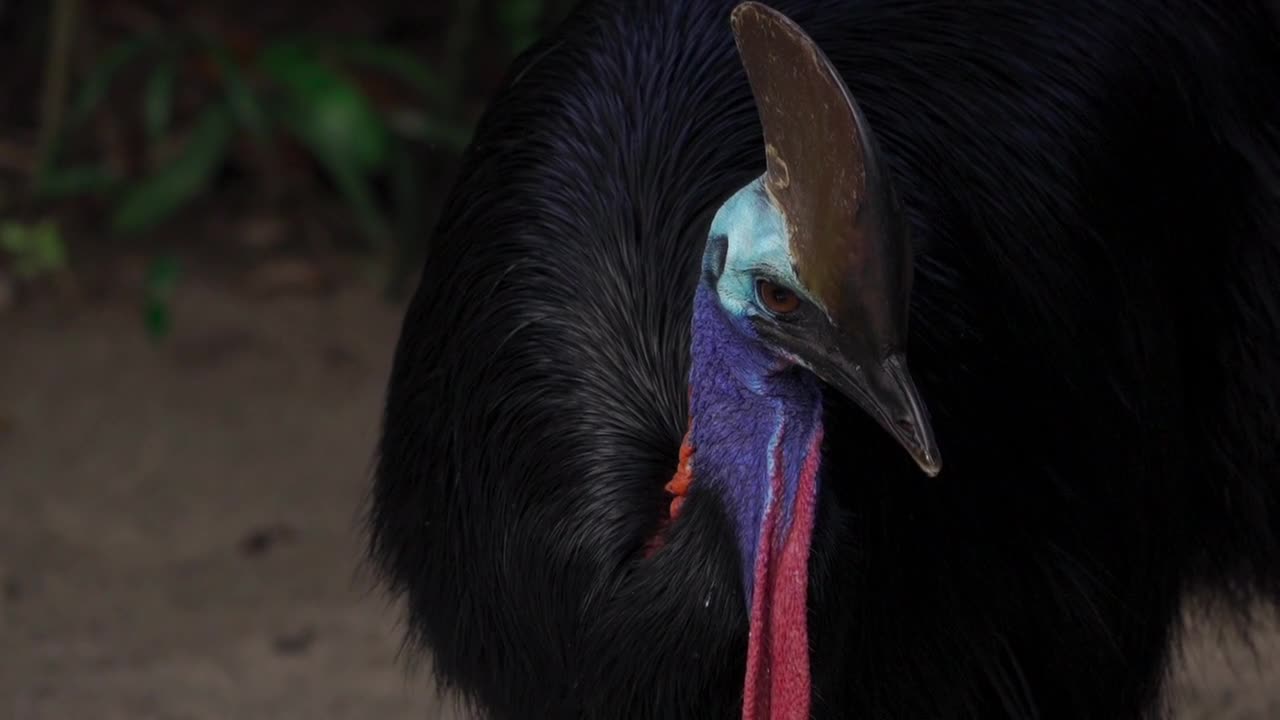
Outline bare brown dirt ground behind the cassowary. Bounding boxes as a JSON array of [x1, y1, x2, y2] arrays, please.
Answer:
[[0, 260, 1280, 720]]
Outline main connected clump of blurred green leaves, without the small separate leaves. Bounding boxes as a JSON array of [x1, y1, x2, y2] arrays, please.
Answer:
[[37, 26, 481, 252]]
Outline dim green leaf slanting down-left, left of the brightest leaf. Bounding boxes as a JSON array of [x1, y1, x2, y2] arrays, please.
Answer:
[[111, 105, 234, 233]]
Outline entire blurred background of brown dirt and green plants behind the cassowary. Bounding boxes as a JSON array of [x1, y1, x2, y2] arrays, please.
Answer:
[[0, 0, 1280, 720]]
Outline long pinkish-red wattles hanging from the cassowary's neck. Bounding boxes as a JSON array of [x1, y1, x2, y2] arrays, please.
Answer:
[[742, 427, 822, 720]]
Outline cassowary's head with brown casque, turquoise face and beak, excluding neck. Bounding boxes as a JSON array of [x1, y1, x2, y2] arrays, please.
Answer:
[[704, 3, 941, 475]]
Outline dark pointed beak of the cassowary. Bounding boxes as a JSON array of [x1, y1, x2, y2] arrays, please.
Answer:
[[814, 352, 942, 478]]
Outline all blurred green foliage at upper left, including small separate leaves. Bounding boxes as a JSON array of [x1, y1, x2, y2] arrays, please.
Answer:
[[28, 0, 570, 338]]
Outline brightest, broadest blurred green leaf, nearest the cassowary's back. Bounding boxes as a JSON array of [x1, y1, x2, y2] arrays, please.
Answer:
[[262, 44, 389, 170]]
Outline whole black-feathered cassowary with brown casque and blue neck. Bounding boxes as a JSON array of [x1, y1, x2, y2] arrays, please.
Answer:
[[370, 0, 1280, 719]]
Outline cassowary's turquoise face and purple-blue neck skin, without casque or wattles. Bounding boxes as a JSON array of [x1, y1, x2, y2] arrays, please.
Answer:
[[690, 181, 822, 602]]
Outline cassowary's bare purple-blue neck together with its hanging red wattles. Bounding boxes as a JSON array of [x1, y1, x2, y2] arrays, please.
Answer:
[[689, 283, 822, 720]]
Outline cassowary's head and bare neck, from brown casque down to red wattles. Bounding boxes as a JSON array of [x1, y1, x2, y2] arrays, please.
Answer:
[[668, 3, 941, 719]]
